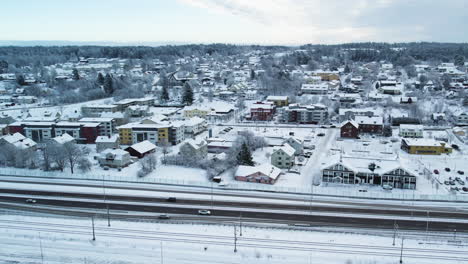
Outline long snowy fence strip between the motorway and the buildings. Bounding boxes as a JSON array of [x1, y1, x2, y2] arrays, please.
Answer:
[[0, 168, 468, 203]]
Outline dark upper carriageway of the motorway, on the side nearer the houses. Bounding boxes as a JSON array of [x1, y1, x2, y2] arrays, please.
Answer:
[[0, 189, 468, 219]]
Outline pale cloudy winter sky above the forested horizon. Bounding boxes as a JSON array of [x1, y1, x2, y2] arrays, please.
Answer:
[[0, 0, 468, 45]]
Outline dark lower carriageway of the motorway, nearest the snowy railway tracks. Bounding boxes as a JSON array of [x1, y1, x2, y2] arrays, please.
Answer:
[[0, 197, 468, 233]]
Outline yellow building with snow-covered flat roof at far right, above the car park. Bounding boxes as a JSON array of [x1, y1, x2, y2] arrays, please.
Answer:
[[401, 138, 452, 155]]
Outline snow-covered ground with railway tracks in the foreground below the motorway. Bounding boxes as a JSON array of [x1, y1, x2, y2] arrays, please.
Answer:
[[0, 212, 468, 264]]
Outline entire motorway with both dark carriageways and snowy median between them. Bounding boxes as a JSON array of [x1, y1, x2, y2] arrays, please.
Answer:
[[0, 182, 468, 233]]
